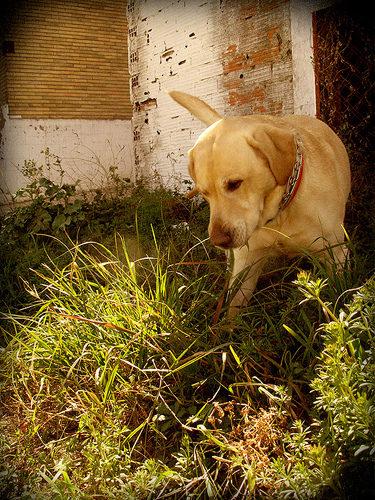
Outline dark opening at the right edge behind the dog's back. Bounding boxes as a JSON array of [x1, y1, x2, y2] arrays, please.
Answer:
[[314, 2, 375, 264]]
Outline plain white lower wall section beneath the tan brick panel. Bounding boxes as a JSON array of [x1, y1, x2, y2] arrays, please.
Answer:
[[0, 106, 134, 204]]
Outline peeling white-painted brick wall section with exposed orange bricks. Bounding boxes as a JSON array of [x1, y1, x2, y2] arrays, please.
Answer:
[[128, 0, 293, 183]]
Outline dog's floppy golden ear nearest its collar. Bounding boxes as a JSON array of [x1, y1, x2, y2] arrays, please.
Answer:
[[247, 124, 296, 186]]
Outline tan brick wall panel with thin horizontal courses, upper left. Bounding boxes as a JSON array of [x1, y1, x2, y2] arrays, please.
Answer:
[[0, 0, 132, 119]]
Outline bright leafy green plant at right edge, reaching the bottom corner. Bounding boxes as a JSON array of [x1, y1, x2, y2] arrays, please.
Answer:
[[275, 272, 375, 498]]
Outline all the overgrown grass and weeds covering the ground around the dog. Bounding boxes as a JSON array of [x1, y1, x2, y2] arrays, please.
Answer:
[[0, 158, 375, 500]]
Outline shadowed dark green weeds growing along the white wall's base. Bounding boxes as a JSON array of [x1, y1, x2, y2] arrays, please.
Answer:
[[0, 158, 215, 308]]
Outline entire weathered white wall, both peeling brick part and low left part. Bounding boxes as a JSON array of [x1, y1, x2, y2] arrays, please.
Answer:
[[0, 0, 332, 207]]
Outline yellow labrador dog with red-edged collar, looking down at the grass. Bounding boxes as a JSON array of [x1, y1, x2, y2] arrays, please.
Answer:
[[169, 91, 350, 316]]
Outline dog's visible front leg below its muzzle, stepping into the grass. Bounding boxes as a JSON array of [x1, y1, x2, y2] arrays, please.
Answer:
[[228, 242, 271, 318]]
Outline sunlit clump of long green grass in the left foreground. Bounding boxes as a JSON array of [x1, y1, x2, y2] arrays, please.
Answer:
[[2, 236, 223, 498]]
